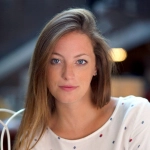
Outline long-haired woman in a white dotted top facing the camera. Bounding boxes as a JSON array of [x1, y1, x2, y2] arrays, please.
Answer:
[[14, 9, 150, 150]]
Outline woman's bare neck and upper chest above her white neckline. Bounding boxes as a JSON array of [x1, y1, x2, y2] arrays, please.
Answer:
[[50, 96, 116, 139]]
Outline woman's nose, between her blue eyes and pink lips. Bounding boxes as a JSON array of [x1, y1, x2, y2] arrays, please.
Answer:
[[62, 64, 74, 80]]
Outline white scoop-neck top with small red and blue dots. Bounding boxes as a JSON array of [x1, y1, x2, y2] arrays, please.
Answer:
[[33, 96, 150, 150]]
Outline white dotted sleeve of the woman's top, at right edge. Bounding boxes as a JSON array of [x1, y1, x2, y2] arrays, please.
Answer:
[[129, 99, 150, 150]]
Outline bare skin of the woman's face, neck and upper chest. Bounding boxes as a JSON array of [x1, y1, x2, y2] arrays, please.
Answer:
[[47, 31, 115, 139]]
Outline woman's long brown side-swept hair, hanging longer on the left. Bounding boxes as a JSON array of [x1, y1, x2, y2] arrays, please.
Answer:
[[14, 8, 112, 150]]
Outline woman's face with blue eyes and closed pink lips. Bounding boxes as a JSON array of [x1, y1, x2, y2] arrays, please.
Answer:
[[47, 31, 96, 103]]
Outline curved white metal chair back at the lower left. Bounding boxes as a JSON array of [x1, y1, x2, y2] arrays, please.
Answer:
[[0, 108, 24, 150]]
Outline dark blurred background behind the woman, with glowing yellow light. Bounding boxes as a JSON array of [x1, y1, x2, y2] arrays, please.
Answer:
[[0, 0, 150, 112]]
